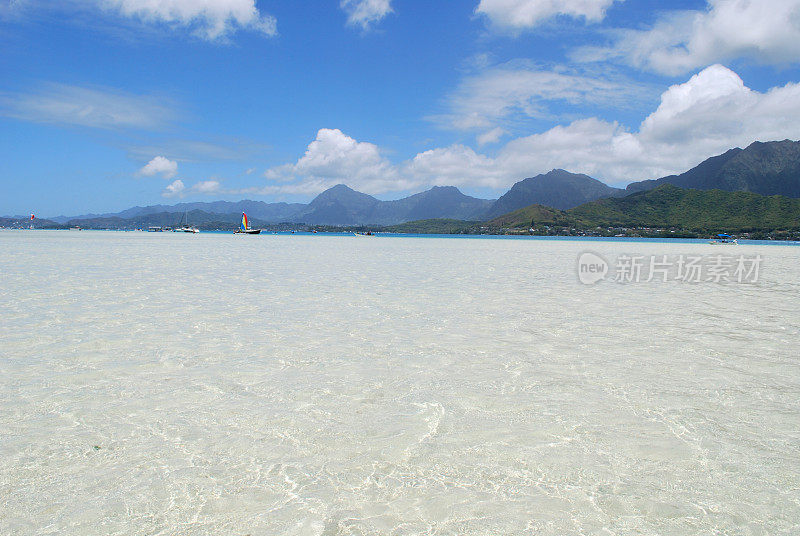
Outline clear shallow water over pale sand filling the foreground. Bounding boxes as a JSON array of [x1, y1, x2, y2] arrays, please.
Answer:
[[0, 231, 800, 536]]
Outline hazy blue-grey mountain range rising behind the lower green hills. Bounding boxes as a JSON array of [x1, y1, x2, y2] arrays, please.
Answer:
[[10, 140, 800, 227]]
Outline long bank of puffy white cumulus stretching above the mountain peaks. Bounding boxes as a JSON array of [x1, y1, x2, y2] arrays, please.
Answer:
[[260, 65, 800, 194]]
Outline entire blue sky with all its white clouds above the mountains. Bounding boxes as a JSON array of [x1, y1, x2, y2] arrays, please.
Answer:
[[0, 0, 800, 216]]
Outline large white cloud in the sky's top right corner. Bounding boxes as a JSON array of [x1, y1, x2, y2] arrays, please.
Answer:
[[575, 0, 800, 75]]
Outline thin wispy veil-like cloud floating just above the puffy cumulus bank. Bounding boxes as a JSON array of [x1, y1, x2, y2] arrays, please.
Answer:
[[430, 60, 650, 135]]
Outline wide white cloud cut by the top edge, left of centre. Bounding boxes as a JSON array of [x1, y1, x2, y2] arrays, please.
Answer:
[[101, 0, 277, 40]]
